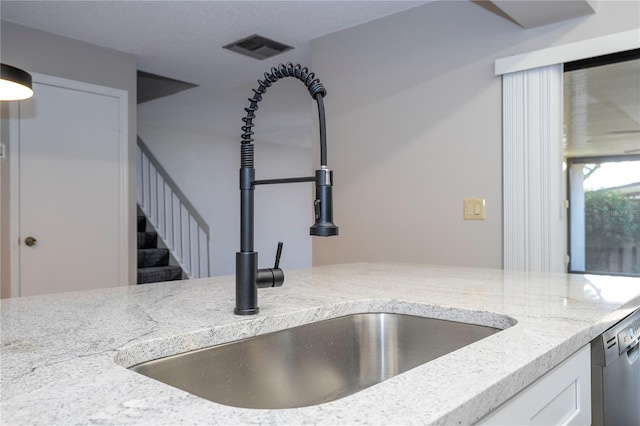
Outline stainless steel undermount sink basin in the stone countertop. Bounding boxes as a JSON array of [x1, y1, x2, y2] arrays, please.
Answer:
[[131, 313, 501, 408]]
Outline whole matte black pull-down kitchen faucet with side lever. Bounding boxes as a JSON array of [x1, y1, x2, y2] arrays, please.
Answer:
[[234, 63, 338, 315]]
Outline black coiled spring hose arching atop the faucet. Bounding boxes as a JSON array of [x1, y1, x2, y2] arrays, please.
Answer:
[[240, 63, 327, 168]]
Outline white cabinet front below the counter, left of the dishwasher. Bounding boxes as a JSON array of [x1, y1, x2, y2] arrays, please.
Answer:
[[478, 345, 591, 425]]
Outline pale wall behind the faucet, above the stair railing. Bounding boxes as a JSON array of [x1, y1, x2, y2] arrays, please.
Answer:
[[138, 76, 318, 275]]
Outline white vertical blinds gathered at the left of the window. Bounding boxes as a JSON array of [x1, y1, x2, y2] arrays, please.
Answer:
[[502, 64, 565, 272]]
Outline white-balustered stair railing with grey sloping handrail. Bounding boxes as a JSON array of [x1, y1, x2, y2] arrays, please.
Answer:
[[136, 136, 210, 278]]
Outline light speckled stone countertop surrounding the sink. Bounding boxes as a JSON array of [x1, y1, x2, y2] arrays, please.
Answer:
[[0, 263, 640, 425]]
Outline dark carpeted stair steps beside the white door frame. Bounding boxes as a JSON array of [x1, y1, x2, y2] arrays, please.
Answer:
[[138, 211, 182, 284]]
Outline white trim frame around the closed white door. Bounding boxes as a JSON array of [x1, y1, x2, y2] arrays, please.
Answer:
[[9, 72, 129, 297]]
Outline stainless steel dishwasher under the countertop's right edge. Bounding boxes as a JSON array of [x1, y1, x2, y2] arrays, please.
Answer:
[[591, 309, 640, 426]]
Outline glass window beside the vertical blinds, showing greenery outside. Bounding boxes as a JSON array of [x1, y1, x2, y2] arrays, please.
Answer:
[[563, 50, 640, 276]]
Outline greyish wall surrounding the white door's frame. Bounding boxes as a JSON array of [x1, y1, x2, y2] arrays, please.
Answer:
[[0, 21, 137, 297]]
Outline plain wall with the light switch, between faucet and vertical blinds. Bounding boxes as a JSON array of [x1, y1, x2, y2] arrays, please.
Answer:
[[312, 1, 640, 267]]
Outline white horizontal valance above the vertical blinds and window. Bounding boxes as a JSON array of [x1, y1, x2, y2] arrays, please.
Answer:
[[495, 29, 640, 75]]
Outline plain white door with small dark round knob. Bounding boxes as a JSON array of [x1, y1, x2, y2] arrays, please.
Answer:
[[14, 77, 127, 296]]
